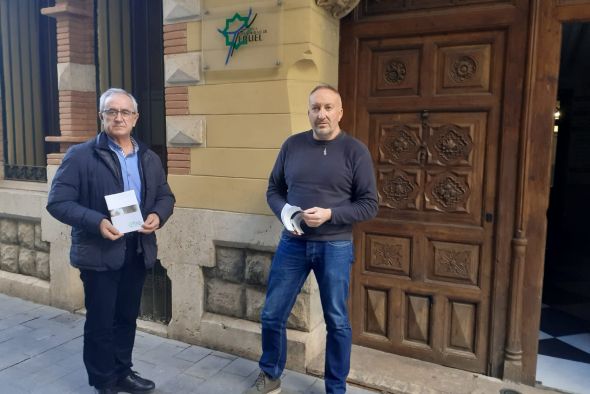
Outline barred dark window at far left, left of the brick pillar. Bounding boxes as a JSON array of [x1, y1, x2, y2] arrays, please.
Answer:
[[0, 0, 59, 182]]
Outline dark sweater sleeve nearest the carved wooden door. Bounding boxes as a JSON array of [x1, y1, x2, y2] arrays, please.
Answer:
[[330, 145, 379, 224]]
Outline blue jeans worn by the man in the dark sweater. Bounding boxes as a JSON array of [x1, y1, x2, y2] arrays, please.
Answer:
[[259, 235, 353, 394]]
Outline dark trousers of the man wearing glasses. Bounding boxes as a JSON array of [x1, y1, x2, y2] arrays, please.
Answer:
[[80, 233, 146, 388]]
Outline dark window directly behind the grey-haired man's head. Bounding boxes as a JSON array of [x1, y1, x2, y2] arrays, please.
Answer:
[[96, 0, 166, 166]]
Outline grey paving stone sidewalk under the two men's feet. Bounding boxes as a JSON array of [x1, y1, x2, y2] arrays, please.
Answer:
[[0, 294, 374, 394]]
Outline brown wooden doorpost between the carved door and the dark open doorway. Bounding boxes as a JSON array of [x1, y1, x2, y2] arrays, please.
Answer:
[[516, 0, 590, 384]]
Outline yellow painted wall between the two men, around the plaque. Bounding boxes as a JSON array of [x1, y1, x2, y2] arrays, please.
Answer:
[[169, 0, 339, 215]]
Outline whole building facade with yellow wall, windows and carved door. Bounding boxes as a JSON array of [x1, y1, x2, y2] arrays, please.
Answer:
[[0, 0, 590, 384]]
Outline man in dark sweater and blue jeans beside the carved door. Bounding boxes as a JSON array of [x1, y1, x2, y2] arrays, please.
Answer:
[[246, 85, 377, 394]]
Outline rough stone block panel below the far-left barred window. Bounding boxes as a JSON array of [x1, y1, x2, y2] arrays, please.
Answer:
[[0, 216, 50, 280]]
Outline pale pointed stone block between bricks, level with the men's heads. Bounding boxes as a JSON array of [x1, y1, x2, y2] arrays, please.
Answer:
[[166, 115, 206, 147]]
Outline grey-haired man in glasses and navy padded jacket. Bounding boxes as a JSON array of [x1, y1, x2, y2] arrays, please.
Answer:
[[47, 89, 175, 394]]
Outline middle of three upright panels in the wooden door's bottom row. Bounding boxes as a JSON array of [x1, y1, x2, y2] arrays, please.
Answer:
[[403, 294, 431, 345]]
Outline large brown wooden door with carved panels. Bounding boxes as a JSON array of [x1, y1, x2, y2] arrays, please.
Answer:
[[340, 1, 526, 373]]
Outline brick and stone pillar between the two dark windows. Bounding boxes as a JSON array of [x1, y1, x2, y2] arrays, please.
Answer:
[[41, 0, 97, 310]]
